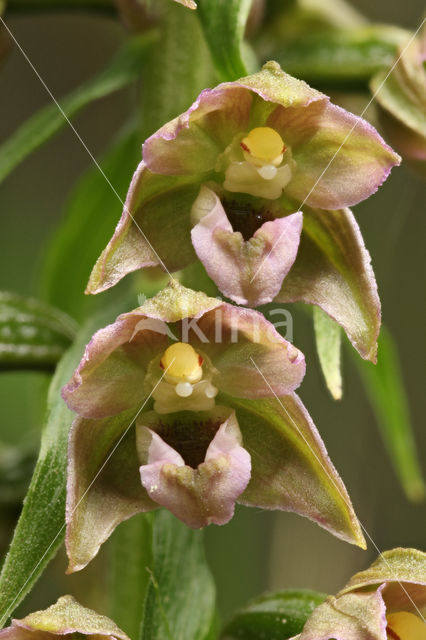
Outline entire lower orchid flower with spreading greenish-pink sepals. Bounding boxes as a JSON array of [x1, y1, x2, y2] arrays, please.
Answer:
[[63, 281, 364, 571]]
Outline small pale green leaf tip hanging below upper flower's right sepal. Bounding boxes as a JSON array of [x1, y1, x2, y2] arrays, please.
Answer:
[[314, 307, 342, 400]]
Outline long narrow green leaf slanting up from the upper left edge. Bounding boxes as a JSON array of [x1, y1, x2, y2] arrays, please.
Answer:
[[0, 32, 157, 182]]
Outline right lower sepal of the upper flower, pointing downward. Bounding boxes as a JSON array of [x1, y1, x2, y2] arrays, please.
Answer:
[[275, 208, 381, 362]]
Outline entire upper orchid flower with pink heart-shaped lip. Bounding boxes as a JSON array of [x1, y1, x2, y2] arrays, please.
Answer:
[[87, 62, 399, 358]]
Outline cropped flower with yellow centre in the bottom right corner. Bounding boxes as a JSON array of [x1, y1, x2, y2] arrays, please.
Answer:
[[293, 548, 426, 640]]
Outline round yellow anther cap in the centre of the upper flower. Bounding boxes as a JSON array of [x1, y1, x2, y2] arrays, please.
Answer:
[[241, 127, 285, 169]]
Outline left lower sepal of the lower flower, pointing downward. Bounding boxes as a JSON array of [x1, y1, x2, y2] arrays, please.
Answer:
[[66, 410, 157, 573]]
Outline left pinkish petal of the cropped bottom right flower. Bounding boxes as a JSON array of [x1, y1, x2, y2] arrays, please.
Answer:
[[299, 589, 387, 640]]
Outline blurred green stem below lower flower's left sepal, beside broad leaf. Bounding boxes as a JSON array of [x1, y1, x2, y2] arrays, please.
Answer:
[[108, 513, 153, 640]]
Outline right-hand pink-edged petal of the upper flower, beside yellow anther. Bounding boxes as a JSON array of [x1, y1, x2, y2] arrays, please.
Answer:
[[267, 99, 401, 209]]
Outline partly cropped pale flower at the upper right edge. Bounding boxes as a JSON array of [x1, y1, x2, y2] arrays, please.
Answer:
[[370, 27, 426, 176]]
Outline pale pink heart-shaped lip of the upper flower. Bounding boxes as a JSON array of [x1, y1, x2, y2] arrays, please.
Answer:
[[191, 187, 302, 307]]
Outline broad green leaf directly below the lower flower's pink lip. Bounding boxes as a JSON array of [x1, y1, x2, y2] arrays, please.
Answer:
[[140, 510, 215, 640]]
